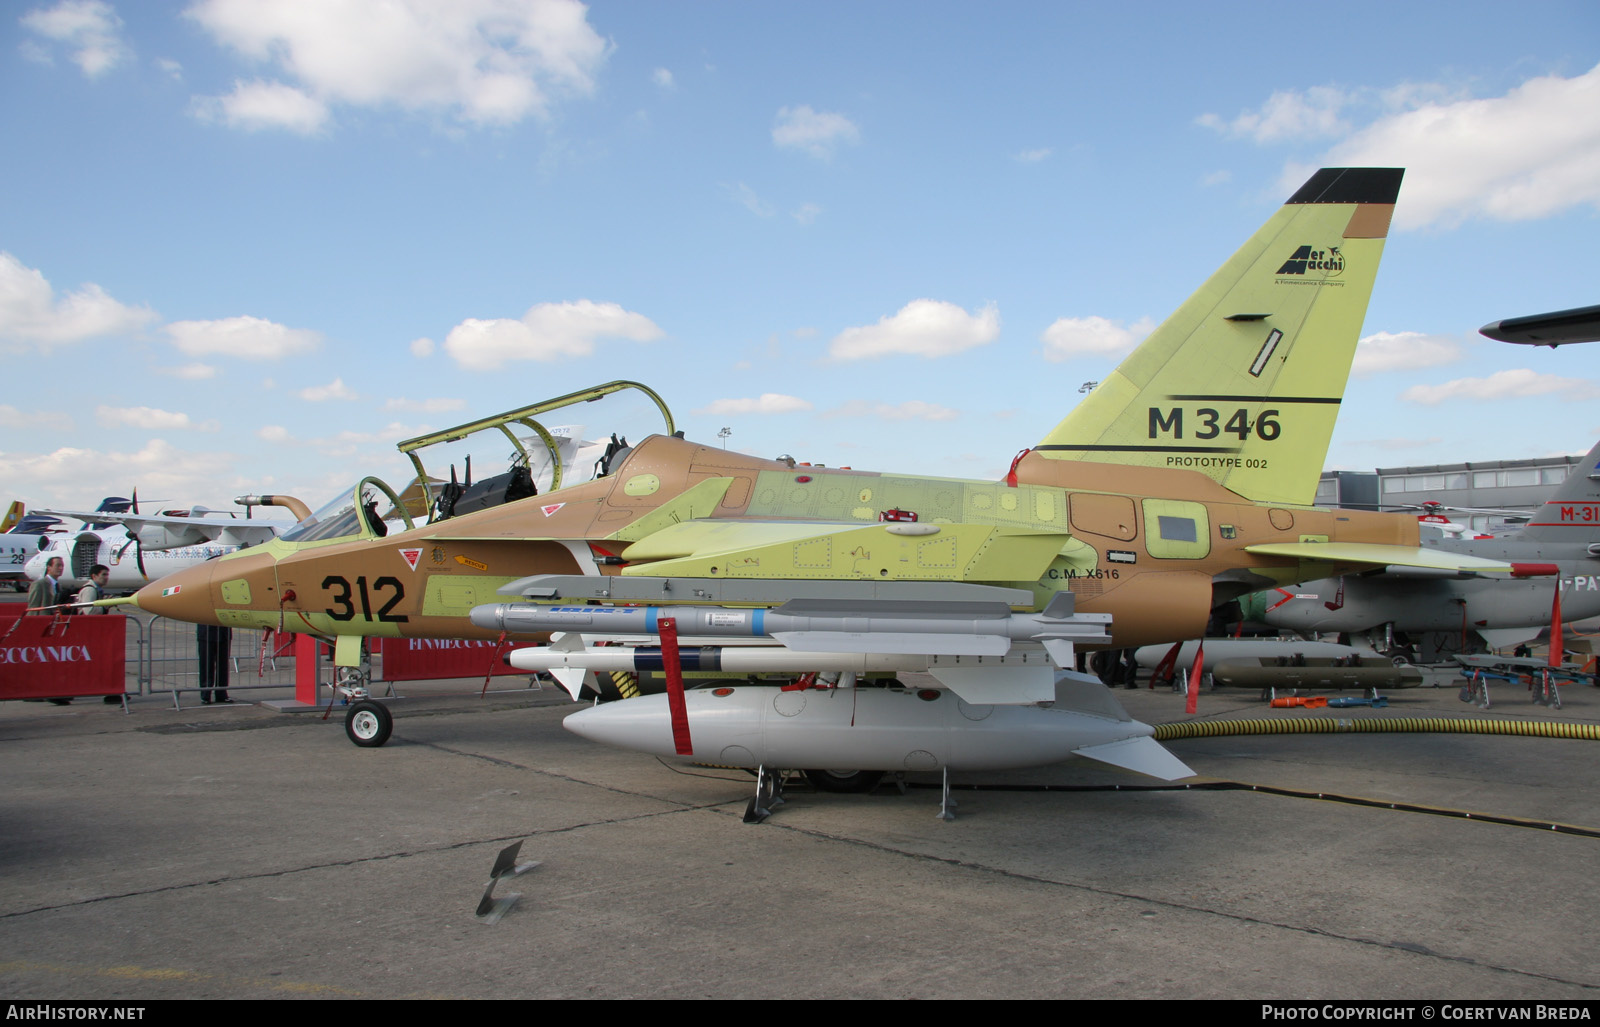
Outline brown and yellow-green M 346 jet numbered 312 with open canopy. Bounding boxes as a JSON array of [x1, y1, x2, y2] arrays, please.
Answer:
[[118, 168, 1509, 806]]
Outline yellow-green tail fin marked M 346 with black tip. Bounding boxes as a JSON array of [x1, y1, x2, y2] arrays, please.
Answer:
[[1037, 168, 1405, 504]]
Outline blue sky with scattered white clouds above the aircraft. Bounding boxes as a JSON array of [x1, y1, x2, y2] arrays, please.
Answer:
[[0, 0, 1600, 507]]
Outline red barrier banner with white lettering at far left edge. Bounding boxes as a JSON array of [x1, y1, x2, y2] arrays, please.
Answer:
[[0, 614, 128, 699]]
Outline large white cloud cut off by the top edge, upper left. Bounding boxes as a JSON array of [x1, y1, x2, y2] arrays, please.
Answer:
[[187, 0, 610, 125]]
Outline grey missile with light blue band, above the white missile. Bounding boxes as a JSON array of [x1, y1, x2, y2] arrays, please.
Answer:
[[470, 592, 1110, 659]]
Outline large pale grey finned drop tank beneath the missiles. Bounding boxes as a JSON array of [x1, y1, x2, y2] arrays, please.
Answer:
[[565, 672, 1194, 781]]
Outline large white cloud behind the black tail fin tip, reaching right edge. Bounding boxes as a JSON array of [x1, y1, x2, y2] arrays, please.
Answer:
[[1328, 66, 1600, 227]]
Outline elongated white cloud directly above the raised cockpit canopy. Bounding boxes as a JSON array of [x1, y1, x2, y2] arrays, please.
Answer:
[[445, 299, 662, 371]]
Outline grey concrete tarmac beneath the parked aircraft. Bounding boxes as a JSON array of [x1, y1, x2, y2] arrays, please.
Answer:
[[0, 659, 1600, 1000]]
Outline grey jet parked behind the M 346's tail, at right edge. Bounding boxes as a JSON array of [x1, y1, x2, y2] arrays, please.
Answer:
[[1240, 443, 1600, 651]]
